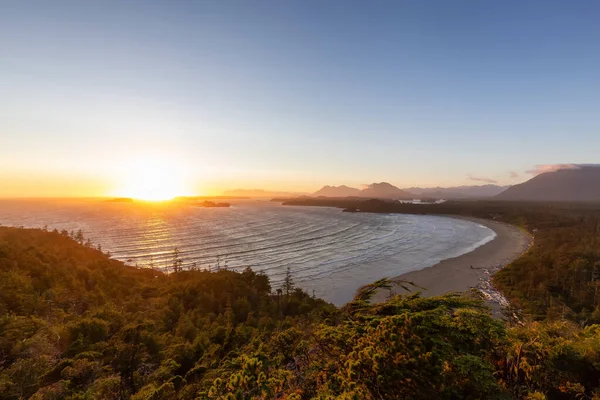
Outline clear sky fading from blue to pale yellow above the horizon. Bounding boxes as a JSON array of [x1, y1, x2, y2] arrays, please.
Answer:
[[0, 0, 600, 197]]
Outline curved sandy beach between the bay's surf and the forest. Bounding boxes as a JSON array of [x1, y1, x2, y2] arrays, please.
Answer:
[[373, 216, 533, 305]]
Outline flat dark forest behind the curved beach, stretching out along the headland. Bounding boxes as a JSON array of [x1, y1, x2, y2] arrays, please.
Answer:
[[285, 199, 600, 323]]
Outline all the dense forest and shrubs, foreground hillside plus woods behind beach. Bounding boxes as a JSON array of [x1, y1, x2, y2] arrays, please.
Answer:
[[0, 198, 600, 400]]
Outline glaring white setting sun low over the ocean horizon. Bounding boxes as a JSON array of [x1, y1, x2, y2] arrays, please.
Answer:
[[118, 159, 189, 201]]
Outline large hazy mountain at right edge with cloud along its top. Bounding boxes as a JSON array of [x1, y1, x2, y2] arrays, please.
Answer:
[[495, 165, 600, 202]]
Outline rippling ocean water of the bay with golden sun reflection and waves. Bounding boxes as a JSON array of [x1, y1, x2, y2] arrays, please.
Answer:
[[0, 200, 495, 305]]
